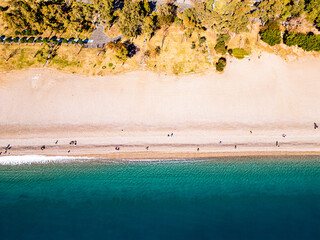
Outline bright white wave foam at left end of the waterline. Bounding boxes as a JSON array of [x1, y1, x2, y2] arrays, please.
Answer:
[[0, 155, 91, 165]]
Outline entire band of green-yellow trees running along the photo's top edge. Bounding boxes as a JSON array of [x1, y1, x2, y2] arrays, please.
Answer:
[[2, 0, 320, 39]]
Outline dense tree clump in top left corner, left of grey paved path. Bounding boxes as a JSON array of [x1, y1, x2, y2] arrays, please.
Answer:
[[2, 0, 94, 34]]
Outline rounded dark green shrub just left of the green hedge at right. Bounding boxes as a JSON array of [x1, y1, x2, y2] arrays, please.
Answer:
[[259, 21, 281, 46]]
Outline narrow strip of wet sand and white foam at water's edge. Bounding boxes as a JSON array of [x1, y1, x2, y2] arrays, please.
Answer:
[[0, 151, 320, 168]]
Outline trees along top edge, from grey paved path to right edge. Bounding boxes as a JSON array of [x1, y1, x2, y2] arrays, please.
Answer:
[[94, 0, 320, 42]]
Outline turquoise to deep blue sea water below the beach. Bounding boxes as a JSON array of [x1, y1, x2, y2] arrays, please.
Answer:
[[0, 157, 320, 240]]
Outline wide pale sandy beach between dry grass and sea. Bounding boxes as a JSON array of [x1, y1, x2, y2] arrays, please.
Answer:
[[0, 53, 320, 159]]
